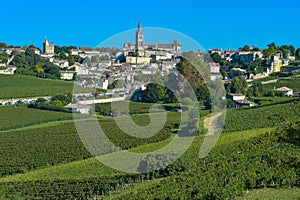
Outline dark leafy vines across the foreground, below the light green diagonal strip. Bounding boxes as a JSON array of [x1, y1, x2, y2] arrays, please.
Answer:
[[0, 124, 300, 199]]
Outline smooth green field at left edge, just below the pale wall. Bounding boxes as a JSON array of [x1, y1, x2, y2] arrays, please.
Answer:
[[0, 107, 73, 130]]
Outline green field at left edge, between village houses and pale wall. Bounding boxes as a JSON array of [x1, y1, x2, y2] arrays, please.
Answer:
[[0, 74, 73, 99]]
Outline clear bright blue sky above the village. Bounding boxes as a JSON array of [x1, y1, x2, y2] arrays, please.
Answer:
[[0, 0, 300, 49]]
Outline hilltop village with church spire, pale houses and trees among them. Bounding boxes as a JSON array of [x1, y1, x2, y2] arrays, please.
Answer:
[[0, 21, 300, 108]]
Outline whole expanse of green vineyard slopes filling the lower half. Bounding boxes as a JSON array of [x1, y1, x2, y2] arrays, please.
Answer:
[[0, 102, 300, 199]]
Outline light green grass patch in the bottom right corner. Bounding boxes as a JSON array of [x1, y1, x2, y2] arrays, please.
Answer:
[[237, 188, 300, 200]]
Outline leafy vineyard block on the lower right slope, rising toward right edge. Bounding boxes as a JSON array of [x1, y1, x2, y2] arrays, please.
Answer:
[[110, 125, 300, 199]]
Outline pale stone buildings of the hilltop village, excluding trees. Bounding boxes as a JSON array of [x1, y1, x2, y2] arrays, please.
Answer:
[[0, 22, 300, 112]]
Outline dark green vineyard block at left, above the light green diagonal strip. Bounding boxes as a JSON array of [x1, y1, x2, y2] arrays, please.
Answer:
[[0, 110, 180, 176]]
